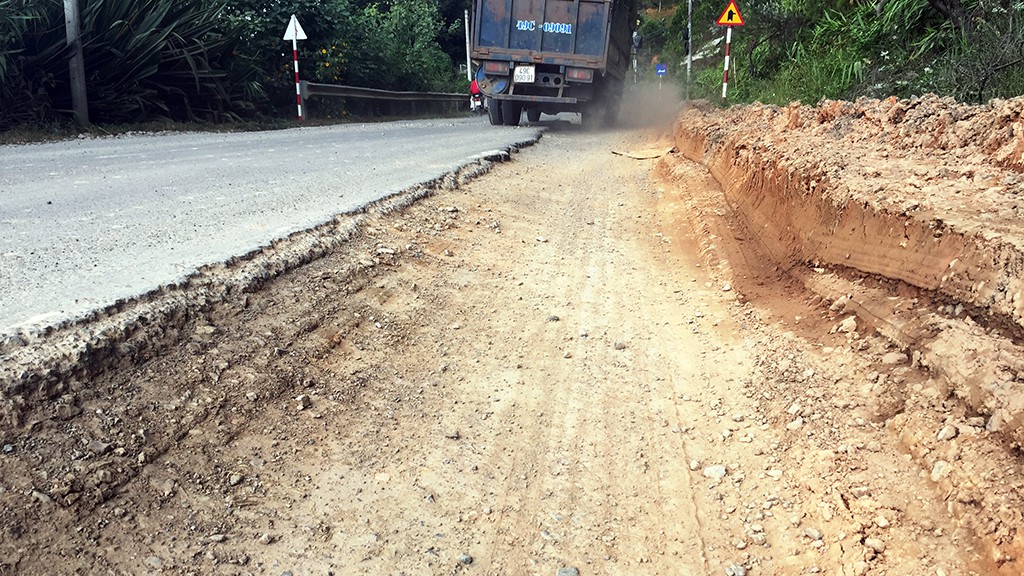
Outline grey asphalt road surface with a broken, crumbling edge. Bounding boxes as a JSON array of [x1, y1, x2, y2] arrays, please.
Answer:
[[0, 118, 541, 336]]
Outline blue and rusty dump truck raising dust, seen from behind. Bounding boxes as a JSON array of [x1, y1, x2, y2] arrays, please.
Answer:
[[470, 0, 636, 126]]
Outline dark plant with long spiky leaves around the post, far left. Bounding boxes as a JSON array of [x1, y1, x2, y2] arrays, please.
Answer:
[[0, 0, 259, 127]]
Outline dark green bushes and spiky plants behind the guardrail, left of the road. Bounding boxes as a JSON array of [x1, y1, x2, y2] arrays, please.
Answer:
[[0, 0, 469, 130]]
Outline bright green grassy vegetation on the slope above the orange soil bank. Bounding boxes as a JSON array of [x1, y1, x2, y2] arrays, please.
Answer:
[[639, 0, 1024, 105]]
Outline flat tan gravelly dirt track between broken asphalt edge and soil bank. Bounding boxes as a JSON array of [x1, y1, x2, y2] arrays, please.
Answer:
[[0, 96, 1022, 576]]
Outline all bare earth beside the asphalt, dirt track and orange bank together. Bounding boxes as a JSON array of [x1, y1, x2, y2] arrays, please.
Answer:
[[0, 97, 1024, 576]]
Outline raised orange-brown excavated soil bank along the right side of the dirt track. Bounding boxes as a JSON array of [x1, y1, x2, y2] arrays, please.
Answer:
[[675, 95, 1024, 563]]
